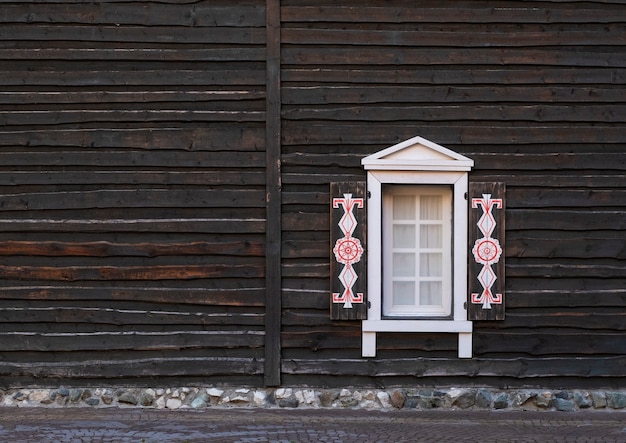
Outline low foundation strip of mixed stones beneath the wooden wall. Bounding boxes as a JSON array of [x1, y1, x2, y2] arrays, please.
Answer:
[[0, 387, 626, 412]]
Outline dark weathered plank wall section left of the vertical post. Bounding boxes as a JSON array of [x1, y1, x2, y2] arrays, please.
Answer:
[[0, 0, 266, 384]]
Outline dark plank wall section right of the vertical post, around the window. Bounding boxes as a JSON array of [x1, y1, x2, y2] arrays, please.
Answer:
[[282, 0, 626, 386]]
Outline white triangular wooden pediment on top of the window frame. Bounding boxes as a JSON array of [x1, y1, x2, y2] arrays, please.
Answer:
[[361, 137, 474, 171]]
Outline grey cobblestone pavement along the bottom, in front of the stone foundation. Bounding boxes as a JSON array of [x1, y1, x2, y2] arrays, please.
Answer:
[[0, 408, 626, 443]]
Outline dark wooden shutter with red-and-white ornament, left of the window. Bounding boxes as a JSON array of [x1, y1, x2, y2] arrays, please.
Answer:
[[330, 182, 367, 320]]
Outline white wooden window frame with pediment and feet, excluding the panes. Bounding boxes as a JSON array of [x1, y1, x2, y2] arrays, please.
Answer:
[[362, 137, 473, 358]]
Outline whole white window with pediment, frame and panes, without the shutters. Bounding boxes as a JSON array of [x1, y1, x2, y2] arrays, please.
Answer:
[[362, 137, 473, 358]]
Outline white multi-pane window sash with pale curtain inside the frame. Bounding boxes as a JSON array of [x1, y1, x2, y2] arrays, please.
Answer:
[[382, 185, 452, 318]]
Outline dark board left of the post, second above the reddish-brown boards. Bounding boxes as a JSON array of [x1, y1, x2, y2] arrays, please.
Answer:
[[0, 189, 265, 211]]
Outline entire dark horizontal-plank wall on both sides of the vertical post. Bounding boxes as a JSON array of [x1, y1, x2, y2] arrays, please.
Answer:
[[0, 0, 626, 387]]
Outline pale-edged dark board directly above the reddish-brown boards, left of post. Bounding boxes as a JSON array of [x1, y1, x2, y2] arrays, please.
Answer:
[[0, 218, 265, 234]]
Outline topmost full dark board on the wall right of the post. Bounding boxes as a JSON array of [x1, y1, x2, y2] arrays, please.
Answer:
[[281, 5, 623, 24]]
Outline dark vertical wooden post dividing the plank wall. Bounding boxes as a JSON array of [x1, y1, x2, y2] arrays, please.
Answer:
[[264, 0, 282, 386]]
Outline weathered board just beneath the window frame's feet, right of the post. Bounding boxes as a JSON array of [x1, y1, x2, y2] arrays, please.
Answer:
[[282, 356, 626, 381]]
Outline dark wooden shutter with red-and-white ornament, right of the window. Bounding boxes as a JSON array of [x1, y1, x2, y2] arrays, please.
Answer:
[[467, 183, 505, 320]]
